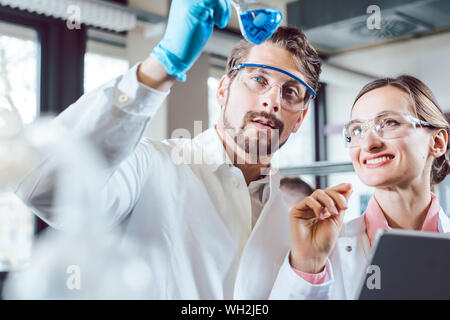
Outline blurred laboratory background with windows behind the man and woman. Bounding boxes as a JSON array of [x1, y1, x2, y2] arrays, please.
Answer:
[[0, 0, 450, 296]]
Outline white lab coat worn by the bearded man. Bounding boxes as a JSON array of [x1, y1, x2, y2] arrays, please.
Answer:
[[17, 66, 302, 299]]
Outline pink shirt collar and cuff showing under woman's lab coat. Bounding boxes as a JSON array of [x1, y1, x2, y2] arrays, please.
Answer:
[[292, 193, 440, 284]]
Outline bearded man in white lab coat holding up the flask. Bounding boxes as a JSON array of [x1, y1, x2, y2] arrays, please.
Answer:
[[16, 0, 320, 299]]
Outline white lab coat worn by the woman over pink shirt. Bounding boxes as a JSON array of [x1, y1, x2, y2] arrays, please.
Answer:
[[271, 208, 450, 300]]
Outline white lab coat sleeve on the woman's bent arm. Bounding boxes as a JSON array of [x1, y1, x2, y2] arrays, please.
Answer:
[[269, 252, 334, 300]]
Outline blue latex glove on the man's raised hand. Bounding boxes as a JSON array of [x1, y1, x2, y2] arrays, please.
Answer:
[[151, 0, 231, 81]]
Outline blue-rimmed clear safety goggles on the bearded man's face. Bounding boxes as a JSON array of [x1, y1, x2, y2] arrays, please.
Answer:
[[231, 63, 317, 112]]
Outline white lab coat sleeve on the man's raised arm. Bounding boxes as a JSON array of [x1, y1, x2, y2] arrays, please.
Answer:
[[16, 65, 169, 228]]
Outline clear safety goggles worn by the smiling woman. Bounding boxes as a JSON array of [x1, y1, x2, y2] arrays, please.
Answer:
[[343, 111, 434, 148]]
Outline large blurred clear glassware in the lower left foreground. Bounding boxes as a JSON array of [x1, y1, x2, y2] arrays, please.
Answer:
[[0, 106, 155, 299]]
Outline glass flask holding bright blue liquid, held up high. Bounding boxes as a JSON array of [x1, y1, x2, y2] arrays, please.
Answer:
[[231, 0, 283, 44]]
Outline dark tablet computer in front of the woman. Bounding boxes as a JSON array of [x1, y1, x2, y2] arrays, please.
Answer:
[[356, 229, 450, 300]]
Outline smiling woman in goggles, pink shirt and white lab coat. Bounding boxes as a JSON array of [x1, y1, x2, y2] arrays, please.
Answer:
[[289, 76, 450, 299]]
